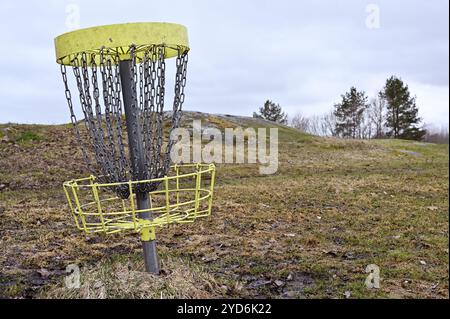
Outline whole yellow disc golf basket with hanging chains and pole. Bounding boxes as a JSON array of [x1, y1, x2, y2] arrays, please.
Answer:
[[55, 23, 215, 273]]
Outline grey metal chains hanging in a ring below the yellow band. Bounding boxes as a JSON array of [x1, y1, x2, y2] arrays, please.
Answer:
[[61, 45, 188, 198]]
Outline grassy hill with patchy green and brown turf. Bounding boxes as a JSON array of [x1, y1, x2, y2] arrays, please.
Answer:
[[0, 113, 449, 298]]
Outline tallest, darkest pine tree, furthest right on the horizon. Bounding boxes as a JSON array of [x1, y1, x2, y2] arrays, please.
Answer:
[[382, 76, 426, 140]]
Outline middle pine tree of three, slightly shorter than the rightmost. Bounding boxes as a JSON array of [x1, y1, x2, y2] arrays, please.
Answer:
[[334, 87, 368, 138]]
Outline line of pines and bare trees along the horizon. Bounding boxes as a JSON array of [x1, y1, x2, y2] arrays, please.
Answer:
[[253, 76, 448, 142]]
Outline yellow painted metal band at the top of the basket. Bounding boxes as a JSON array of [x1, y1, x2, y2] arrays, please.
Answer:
[[55, 22, 189, 65]]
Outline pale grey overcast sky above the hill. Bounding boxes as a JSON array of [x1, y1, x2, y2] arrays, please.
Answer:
[[0, 0, 449, 125]]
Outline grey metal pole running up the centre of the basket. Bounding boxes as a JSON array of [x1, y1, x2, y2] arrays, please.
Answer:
[[119, 60, 159, 274]]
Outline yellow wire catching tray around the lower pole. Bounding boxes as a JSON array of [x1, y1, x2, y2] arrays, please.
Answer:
[[63, 164, 216, 240]]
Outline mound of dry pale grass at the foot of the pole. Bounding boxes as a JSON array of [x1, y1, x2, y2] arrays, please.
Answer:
[[39, 256, 224, 299]]
